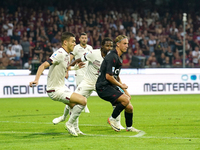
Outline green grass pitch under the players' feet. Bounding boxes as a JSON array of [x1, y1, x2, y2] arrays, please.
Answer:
[[0, 95, 200, 150]]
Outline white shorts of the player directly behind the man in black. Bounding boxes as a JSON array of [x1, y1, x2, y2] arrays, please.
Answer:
[[75, 80, 96, 98]]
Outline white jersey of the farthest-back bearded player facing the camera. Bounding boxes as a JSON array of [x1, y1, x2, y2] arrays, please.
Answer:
[[71, 44, 93, 76]]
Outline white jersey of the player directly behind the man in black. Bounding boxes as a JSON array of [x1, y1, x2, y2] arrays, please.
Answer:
[[81, 49, 103, 84]]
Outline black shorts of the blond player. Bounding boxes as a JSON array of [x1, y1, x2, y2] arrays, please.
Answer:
[[96, 85, 123, 105]]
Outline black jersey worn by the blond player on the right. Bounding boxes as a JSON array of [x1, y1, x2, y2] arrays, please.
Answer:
[[96, 50, 122, 89]]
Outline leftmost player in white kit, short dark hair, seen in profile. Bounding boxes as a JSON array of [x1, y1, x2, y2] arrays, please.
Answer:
[[29, 32, 87, 136]]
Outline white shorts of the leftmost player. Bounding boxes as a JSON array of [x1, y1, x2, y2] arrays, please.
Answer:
[[47, 87, 73, 104]]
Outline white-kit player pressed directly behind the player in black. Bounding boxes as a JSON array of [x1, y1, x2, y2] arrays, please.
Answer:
[[53, 38, 124, 134]]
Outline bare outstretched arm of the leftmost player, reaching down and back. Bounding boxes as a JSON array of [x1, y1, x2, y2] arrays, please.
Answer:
[[29, 61, 50, 87]]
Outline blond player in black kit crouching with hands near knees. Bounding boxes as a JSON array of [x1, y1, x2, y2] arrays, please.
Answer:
[[96, 35, 140, 132]]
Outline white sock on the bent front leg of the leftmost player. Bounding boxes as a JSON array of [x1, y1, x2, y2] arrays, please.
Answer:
[[68, 104, 85, 124]]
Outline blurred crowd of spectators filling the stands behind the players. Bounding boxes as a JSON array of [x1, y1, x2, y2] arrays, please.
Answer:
[[0, 0, 200, 69]]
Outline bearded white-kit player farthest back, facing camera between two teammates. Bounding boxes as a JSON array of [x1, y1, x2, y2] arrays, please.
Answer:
[[70, 32, 93, 113]]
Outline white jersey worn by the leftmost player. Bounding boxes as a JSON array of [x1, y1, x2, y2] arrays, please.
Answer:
[[47, 48, 70, 90]]
